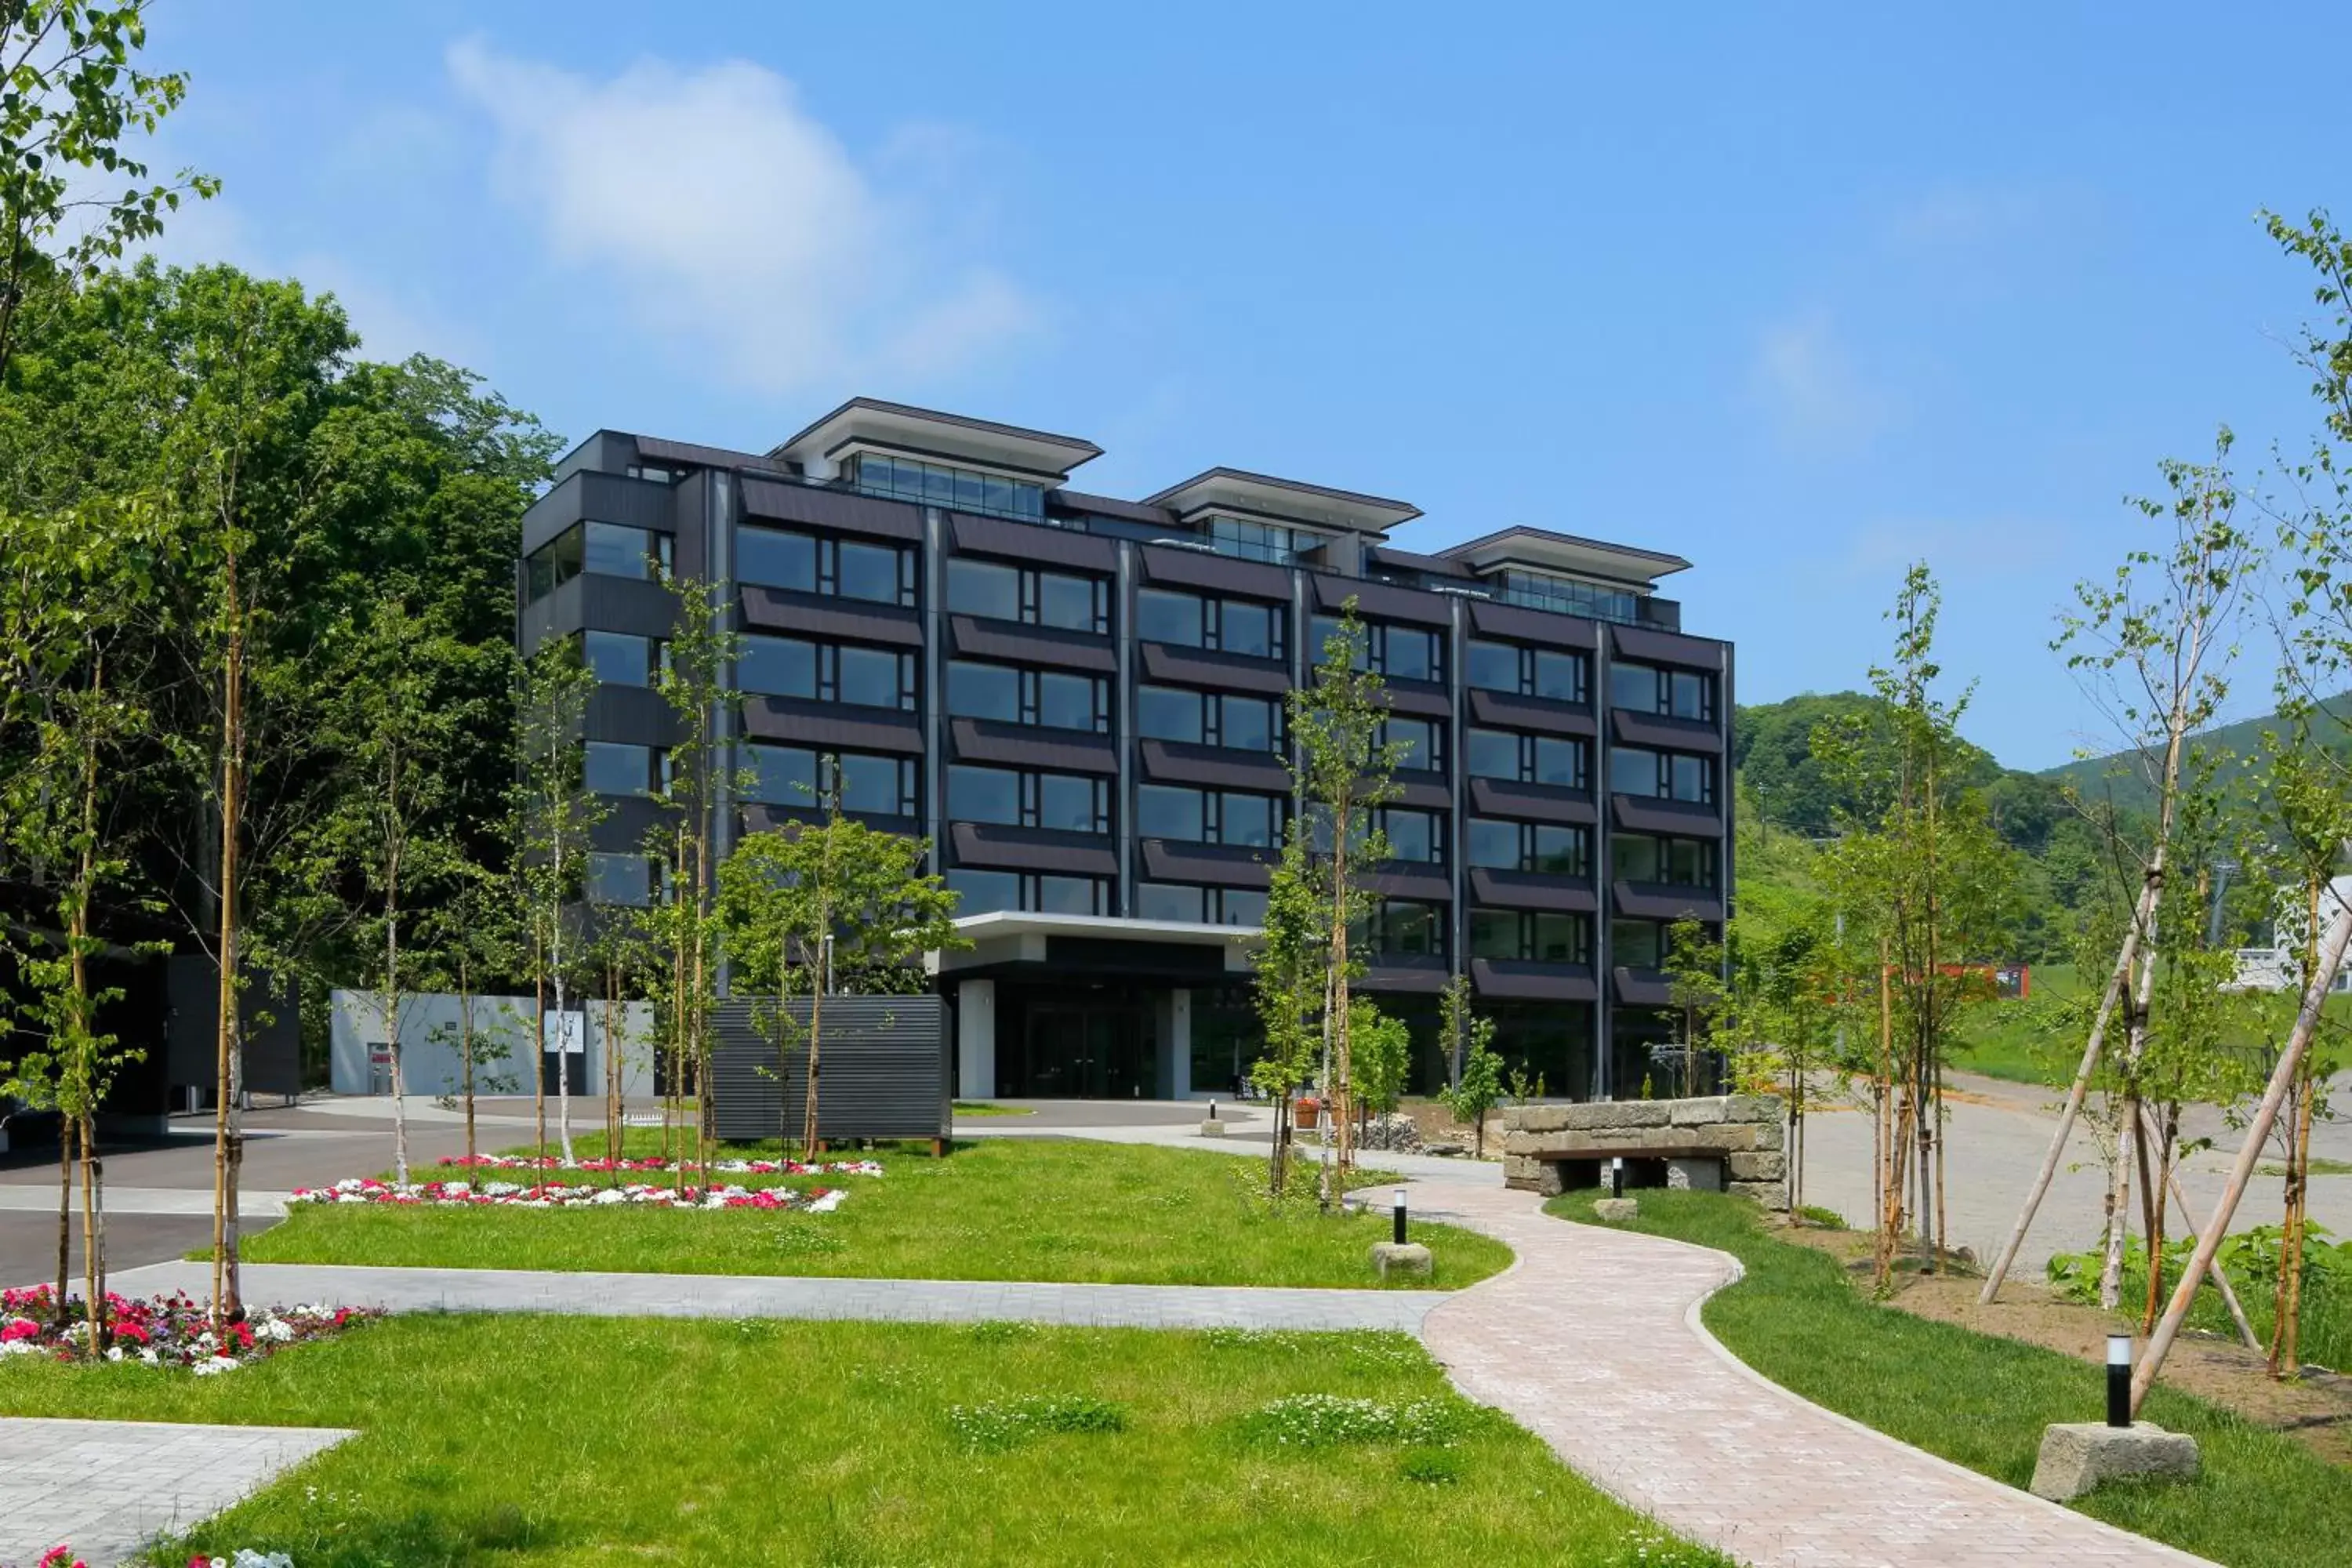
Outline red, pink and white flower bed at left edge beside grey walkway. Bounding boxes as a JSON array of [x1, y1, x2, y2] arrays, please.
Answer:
[[0, 1286, 383, 1375]]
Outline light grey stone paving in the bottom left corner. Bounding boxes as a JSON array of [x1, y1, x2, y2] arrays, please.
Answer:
[[0, 1417, 350, 1568]]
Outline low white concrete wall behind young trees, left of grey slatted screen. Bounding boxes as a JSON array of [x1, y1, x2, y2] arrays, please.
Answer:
[[327, 989, 654, 1095]]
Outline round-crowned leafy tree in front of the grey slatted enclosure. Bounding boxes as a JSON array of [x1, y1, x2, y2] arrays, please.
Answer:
[[717, 799, 964, 1156]]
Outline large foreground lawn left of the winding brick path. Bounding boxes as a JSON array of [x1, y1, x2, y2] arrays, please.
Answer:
[[0, 1316, 1729, 1568]]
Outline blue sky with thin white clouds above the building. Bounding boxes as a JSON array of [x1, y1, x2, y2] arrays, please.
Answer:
[[151, 0, 2352, 767]]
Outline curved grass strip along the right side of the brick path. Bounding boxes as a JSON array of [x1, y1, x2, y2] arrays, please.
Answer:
[[1548, 1192, 2352, 1568]]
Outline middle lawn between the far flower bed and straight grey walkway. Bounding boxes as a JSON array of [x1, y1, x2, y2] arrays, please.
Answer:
[[245, 1138, 1510, 1288]]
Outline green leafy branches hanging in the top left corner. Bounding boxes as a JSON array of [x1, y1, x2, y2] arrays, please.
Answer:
[[0, 0, 221, 376]]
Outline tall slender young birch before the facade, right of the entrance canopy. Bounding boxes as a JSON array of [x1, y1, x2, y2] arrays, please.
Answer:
[[1289, 600, 1409, 1189]]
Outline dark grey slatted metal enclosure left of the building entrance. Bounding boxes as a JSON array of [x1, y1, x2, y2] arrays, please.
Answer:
[[710, 996, 950, 1140]]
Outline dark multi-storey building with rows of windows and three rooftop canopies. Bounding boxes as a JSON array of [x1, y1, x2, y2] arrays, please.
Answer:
[[520, 397, 1733, 1098]]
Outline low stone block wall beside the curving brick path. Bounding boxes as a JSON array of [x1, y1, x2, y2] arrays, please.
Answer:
[[1503, 1095, 1788, 1208]]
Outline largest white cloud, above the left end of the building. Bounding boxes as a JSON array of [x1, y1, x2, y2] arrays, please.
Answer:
[[449, 40, 1037, 390]]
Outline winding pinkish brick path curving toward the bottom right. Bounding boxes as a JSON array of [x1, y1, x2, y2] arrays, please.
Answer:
[[1421, 1187, 2204, 1568]]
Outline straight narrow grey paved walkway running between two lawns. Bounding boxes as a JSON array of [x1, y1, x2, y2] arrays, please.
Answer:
[[113, 1262, 1444, 1333]]
